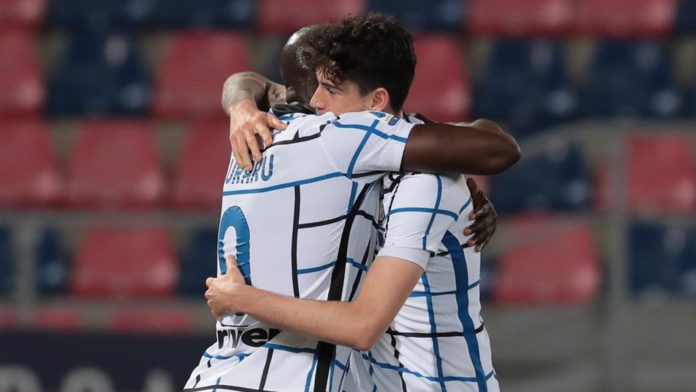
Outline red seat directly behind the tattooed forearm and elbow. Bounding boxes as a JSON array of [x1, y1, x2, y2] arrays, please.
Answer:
[[153, 32, 251, 118]]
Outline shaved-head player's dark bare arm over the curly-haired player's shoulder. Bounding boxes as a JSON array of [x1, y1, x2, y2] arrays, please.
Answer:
[[402, 120, 521, 175]]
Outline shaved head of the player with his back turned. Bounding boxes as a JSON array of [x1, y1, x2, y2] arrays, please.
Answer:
[[280, 24, 325, 104]]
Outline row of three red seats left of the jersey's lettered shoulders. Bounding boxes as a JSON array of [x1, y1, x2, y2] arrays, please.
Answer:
[[0, 120, 230, 209]]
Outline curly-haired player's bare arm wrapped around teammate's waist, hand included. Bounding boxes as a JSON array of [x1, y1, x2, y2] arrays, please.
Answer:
[[205, 256, 423, 350]]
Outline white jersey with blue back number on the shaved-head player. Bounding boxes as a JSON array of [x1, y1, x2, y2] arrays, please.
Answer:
[[185, 112, 413, 391]]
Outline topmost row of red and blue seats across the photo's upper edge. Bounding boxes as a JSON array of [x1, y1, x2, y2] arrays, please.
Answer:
[[6, 0, 696, 37]]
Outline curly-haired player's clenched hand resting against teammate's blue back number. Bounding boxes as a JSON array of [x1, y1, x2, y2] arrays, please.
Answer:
[[205, 256, 245, 318]]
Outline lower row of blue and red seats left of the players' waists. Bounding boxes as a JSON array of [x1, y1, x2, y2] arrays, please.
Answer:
[[0, 227, 218, 298]]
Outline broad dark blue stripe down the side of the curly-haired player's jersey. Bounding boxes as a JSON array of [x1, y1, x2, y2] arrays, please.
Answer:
[[442, 231, 488, 392]]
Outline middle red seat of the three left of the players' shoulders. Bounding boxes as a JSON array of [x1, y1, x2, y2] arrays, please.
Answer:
[[67, 120, 164, 208]]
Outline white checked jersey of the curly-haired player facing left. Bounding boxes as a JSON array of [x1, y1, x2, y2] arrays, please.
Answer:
[[347, 174, 499, 391]]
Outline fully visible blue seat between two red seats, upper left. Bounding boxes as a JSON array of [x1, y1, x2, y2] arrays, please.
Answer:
[[46, 33, 151, 115]]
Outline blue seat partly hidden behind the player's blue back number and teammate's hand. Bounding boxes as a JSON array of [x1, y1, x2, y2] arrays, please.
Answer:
[[178, 228, 218, 296]]
